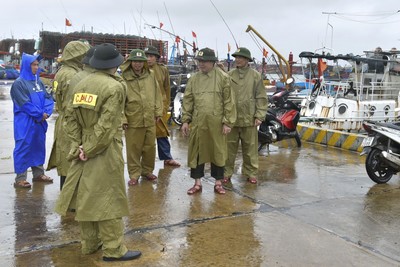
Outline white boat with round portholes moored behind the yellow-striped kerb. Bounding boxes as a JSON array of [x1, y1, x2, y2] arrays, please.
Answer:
[[299, 49, 400, 132]]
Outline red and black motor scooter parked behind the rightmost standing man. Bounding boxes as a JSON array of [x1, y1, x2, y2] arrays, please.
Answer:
[[258, 90, 301, 151]]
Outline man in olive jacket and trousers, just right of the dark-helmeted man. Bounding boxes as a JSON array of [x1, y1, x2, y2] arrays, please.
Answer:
[[122, 49, 163, 186]]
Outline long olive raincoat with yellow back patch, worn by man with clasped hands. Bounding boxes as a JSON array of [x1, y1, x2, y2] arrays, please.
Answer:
[[55, 70, 128, 221]]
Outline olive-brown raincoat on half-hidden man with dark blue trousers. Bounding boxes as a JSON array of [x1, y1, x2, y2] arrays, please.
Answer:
[[150, 64, 171, 138]]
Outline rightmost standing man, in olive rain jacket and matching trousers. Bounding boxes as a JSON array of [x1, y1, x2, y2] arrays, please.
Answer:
[[223, 47, 268, 184]]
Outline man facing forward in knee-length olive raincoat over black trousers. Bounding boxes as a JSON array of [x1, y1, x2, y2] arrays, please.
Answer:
[[181, 48, 236, 195]]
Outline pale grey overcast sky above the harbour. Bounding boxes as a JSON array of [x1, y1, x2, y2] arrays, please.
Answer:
[[0, 0, 400, 63]]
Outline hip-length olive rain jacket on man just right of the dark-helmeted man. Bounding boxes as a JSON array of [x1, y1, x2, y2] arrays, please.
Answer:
[[122, 65, 163, 127]]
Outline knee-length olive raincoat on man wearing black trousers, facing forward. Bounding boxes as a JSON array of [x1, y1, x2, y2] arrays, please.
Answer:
[[182, 67, 236, 168]]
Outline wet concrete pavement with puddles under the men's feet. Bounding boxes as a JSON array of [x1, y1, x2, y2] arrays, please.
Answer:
[[0, 85, 400, 266]]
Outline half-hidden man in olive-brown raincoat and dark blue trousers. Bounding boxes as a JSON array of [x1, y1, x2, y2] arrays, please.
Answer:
[[144, 46, 181, 167]]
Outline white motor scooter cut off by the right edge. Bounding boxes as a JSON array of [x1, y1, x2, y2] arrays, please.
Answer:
[[360, 121, 400, 184]]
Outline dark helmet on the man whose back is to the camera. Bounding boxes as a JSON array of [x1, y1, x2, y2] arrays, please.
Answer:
[[89, 43, 124, 70]]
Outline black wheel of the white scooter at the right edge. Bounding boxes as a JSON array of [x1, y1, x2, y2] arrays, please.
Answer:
[[365, 148, 396, 184]]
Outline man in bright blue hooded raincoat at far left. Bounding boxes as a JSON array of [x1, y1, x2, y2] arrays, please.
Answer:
[[10, 53, 54, 188]]
